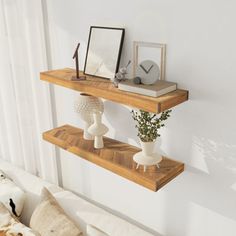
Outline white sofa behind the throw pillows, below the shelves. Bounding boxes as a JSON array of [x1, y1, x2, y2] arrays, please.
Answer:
[[0, 160, 153, 236]]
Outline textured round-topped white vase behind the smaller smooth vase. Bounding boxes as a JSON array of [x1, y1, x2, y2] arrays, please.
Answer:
[[75, 93, 104, 140]]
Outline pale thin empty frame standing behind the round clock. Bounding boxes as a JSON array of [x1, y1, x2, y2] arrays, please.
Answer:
[[133, 41, 166, 80]]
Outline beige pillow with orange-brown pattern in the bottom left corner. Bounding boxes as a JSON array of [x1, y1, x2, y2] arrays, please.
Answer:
[[0, 203, 40, 236]]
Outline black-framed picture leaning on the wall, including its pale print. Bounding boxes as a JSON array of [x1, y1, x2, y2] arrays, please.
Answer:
[[84, 26, 125, 79]]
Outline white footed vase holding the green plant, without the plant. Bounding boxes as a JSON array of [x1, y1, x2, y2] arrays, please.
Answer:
[[133, 140, 162, 171]]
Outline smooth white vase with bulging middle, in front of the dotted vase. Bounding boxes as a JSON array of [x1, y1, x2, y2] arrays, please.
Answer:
[[88, 112, 108, 149]]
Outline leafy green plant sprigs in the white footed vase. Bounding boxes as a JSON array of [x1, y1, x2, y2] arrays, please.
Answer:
[[131, 110, 171, 142]]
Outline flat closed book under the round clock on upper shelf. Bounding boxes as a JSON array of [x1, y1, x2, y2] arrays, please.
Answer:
[[118, 80, 177, 97]]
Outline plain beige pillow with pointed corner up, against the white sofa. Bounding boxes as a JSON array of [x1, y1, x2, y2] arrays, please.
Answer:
[[30, 188, 82, 236]]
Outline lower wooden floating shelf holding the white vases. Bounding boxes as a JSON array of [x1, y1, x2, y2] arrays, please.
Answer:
[[43, 125, 184, 191]]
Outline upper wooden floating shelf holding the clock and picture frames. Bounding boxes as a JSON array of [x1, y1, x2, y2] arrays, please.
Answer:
[[40, 68, 188, 113]]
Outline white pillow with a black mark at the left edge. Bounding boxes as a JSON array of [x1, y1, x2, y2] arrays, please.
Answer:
[[0, 170, 25, 217]]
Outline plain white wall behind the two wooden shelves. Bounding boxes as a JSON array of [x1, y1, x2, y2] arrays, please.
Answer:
[[45, 0, 236, 236]]
